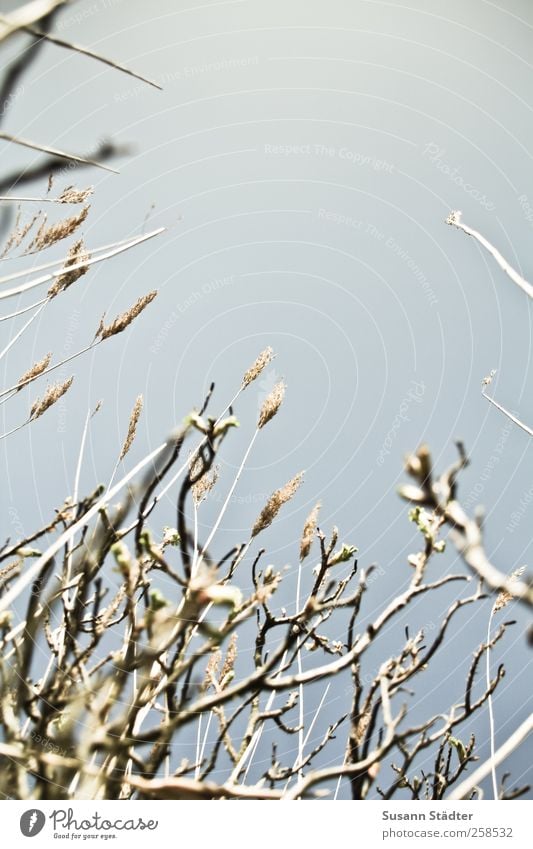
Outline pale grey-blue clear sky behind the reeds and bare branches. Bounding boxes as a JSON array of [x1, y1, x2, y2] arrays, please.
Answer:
[[0, 0, 533, 796]]
